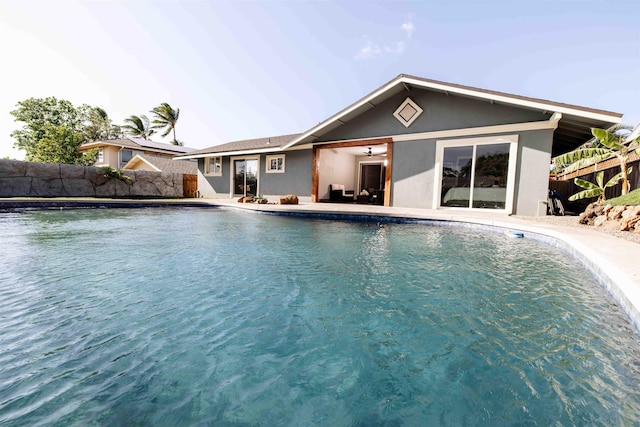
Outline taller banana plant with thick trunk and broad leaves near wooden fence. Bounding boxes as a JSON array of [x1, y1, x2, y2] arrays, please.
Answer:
[[552, 127, 640, 195]]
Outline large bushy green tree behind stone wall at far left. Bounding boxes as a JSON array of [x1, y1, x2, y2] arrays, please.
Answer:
[[11, 97, 96, 164]]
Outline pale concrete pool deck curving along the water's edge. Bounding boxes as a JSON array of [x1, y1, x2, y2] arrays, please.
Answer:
[[0, 198, 640, 332]]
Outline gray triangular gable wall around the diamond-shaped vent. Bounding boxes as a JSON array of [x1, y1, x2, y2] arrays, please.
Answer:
[[321, 89, 551, 141]]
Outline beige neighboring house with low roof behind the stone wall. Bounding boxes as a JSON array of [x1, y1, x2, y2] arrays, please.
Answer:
[[79, 138, 194, 169]]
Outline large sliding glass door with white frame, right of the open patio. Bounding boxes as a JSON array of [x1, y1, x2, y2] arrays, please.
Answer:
[[434, 135, 518, 212]]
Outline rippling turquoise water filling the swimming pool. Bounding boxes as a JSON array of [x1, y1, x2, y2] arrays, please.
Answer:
[[0, 209, 640, 426]]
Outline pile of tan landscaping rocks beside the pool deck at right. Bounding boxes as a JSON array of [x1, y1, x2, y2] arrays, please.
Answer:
[[578, 203, 640, 233]]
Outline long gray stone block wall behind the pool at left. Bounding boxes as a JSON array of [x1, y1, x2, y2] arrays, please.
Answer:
[[0, 160, 183, 197]]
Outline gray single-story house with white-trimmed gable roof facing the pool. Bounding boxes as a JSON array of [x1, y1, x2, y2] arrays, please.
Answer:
[[177, 75, 622, 215]]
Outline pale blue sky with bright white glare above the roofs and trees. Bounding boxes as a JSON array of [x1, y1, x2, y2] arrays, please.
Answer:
[[0, 0, 640, 158]]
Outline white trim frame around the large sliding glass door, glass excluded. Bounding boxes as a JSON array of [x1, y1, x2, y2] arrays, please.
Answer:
[[432, 135, 518, 214]]
